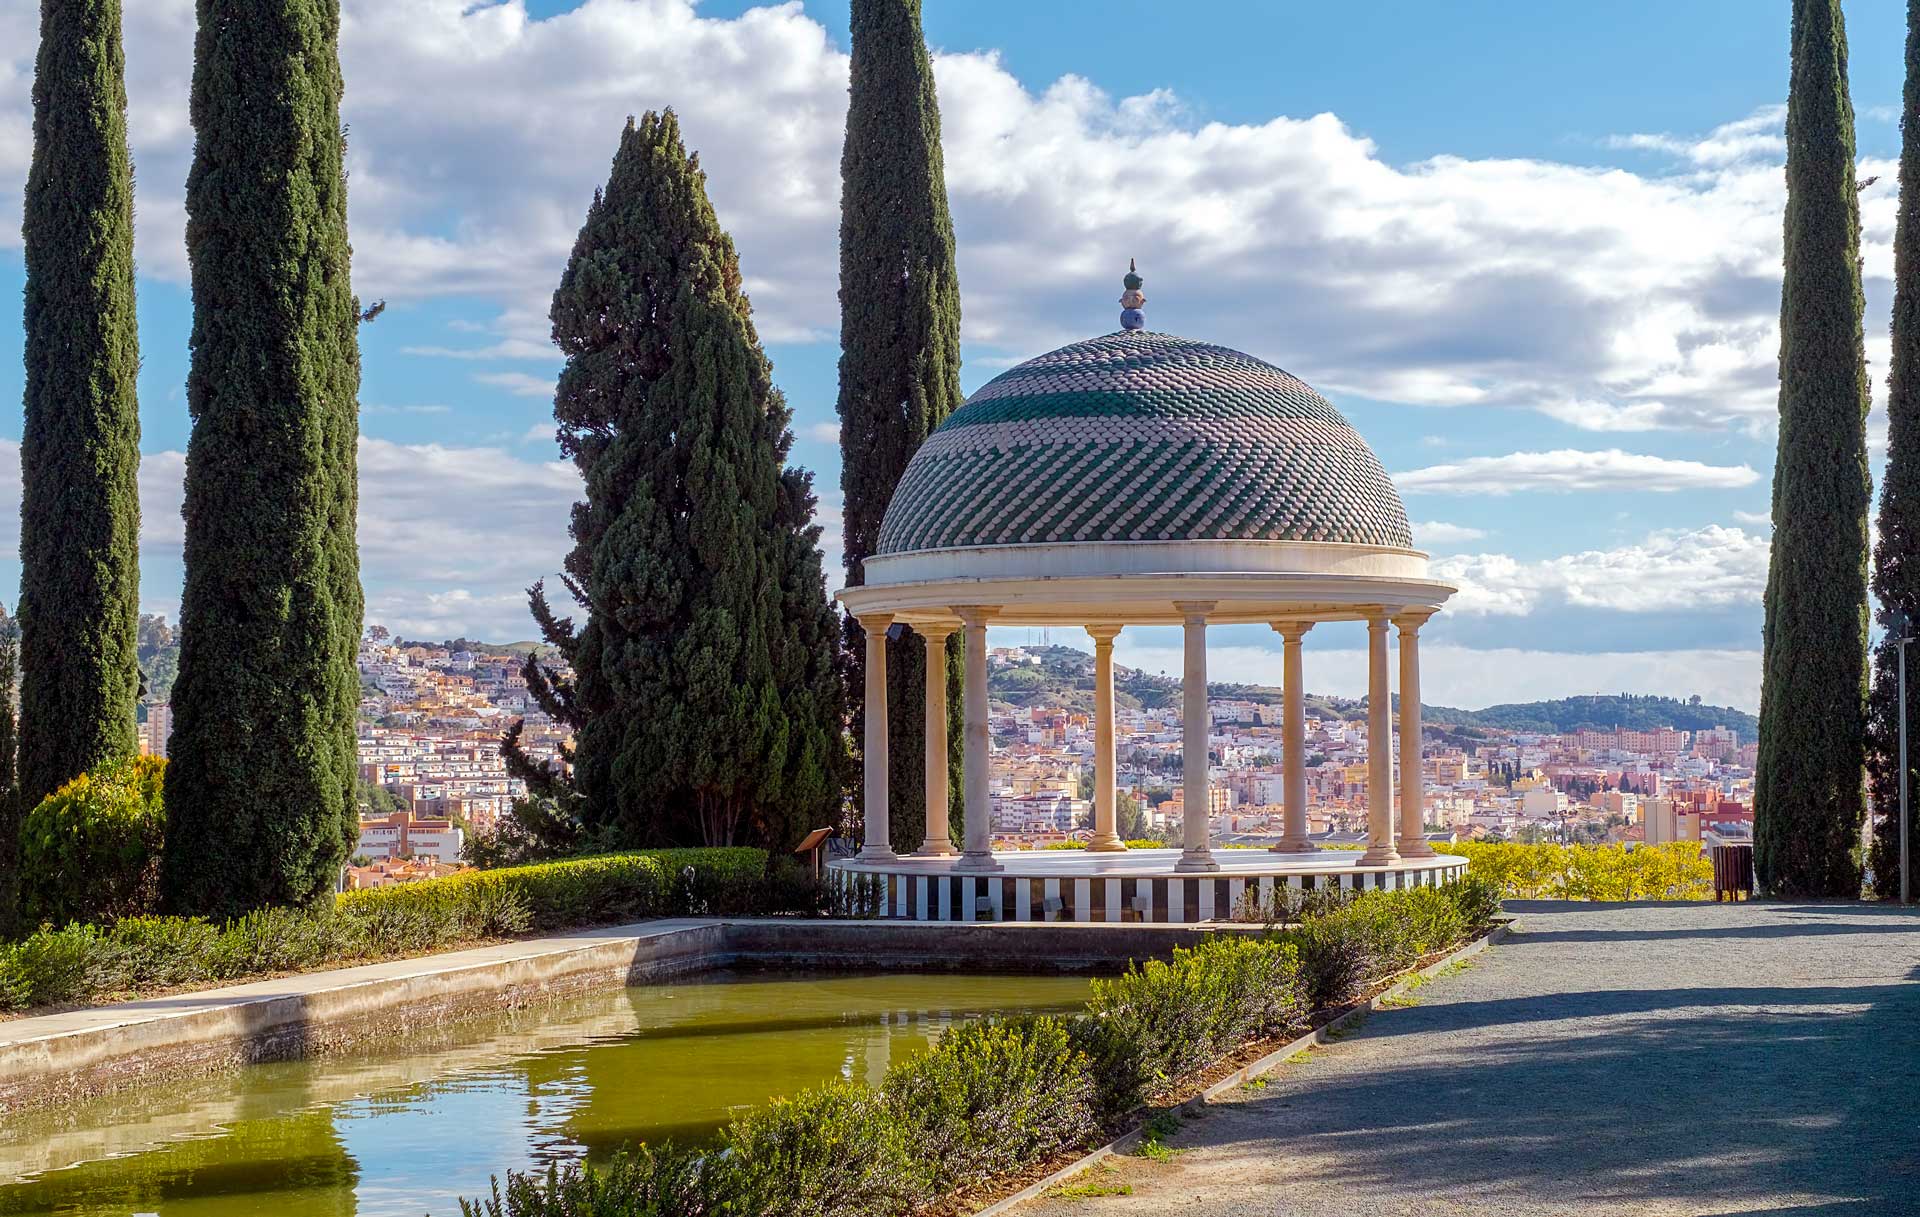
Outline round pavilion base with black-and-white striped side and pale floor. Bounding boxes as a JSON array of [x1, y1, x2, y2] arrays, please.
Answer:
[[828, 848, 1467, 923]]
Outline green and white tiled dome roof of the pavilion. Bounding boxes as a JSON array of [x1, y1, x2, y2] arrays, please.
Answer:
[[879, 328, 1413, 555]]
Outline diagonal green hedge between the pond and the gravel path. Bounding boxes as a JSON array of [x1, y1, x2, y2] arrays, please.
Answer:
[[461, 877, 1500, 1217]]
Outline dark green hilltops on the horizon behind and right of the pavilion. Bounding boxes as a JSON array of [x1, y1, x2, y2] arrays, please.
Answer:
[[987, 647, 1759, 743]]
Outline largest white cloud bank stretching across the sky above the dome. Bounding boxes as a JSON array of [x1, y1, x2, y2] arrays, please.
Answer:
[[0, 0, 1866, 432]]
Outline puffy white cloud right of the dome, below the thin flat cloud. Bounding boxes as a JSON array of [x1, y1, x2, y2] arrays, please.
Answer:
[[1432, 524, 1768, 616]]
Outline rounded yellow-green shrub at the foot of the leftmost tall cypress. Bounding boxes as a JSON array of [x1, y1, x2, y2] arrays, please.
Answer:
[[19, 756, 167, 925]]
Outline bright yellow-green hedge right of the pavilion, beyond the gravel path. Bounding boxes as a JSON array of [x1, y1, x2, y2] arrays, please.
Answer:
[[1434, 841, 1713, 900]]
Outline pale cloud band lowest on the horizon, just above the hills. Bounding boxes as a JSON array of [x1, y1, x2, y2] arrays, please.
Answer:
[[1105, 626, 1761, 710]]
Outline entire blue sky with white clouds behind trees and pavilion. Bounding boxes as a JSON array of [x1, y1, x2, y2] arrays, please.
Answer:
[[0, 0, 1905, 708]]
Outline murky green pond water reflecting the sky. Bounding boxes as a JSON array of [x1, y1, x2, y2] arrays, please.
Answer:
[[0, 973, 1087, 1217]]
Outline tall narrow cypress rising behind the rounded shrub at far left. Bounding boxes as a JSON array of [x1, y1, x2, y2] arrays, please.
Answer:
[[19, 0, 140, 802]]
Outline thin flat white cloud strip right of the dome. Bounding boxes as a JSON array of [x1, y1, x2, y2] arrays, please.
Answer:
[[1394, 447, 1761, 495]]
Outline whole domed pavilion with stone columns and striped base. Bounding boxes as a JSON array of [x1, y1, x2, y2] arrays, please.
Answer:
[[833, 269, 1465, 921]]
